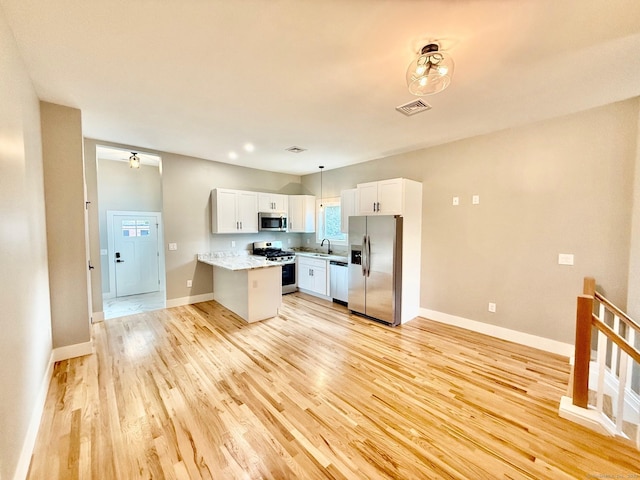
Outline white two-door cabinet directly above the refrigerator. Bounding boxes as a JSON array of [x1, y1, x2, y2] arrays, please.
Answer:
[[357, 178, 418, 215]]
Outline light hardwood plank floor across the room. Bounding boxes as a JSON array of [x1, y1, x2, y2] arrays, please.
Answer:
[[29, 294, 640, 480]]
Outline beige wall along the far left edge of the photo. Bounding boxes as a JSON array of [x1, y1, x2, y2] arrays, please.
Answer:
[[0, 8, 52, 479]]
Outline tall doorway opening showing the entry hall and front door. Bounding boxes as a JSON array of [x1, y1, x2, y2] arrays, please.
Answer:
[[96, 146, 166, 320]]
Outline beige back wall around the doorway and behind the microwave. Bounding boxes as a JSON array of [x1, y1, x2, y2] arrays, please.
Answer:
[[85, 139, 303, 312]]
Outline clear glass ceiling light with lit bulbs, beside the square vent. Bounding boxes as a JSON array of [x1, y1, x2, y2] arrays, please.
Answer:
[[407, 43, 453, 97]]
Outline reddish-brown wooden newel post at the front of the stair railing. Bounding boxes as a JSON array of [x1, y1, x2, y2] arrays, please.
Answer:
[[573, 292, 593, 408]]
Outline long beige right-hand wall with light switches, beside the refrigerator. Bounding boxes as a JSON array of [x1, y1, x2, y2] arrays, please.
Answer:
[[302, 99, 638, 343]]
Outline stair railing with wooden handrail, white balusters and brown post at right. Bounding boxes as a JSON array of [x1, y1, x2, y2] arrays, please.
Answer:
[[572, 277, 640, 448]]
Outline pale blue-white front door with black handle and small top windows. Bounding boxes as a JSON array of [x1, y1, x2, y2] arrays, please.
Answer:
[[112, 214, 160, 297]]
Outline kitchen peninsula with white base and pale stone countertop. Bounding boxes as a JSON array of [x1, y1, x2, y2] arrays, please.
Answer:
[[198, 252, 282, 323]]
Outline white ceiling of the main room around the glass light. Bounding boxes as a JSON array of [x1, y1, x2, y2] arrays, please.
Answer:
[[0, 0, 640, 174]]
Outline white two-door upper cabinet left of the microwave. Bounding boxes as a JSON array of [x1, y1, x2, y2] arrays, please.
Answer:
[[211, 188, 258, 233]]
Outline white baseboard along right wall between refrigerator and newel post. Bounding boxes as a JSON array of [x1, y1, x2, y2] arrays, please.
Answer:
[[420, 308, 574, 357]]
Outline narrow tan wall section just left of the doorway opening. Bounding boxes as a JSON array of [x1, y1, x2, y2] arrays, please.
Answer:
[[40, 102, 91, 348]]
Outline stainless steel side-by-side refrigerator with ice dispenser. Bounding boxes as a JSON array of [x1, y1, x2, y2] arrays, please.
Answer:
[[348, 215, 402, 325]]
